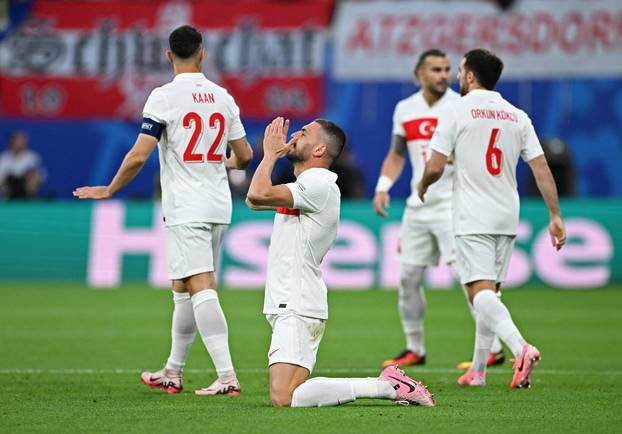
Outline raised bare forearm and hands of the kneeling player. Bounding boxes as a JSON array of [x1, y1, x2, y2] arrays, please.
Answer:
[[246, 117, 294, 209]]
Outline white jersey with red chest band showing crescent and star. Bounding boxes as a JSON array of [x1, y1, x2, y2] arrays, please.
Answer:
[[393, 89, 460, 208]]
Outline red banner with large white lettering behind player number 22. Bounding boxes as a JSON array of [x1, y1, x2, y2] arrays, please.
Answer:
[[0, 0, 333, 119]]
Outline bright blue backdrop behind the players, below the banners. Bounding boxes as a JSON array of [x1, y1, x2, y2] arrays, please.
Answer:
[[0, 3, 622, 199]]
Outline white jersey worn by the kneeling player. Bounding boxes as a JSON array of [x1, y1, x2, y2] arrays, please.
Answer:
[[263, 168, 341, 319]]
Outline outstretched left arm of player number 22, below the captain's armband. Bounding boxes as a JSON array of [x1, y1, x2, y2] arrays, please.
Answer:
[[73, 133, 158, 199]]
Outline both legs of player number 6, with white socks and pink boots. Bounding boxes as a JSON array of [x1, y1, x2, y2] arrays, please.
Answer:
[[459, 280, 540, 388]]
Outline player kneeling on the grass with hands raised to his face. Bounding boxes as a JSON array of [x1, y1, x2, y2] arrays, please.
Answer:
[[247, 118, 434, 407]]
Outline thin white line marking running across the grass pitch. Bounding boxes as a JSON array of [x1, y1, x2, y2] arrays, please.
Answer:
[[0, 368, 622, 377]]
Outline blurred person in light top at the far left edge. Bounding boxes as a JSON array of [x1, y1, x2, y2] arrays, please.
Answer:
[[0, 131, 45, 200]]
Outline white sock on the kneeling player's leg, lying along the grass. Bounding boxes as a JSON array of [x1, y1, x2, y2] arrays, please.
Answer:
[[291, 377, 396, 407]]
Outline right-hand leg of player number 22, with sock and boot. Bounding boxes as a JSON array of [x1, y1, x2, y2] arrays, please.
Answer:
[[184, 272, 240, 395]]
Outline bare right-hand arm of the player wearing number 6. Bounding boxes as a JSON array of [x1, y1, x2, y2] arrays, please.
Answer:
[[527, 155, 566, 250]]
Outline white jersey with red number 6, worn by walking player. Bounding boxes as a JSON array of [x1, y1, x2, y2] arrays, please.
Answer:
[[430, 89, 543, 235]]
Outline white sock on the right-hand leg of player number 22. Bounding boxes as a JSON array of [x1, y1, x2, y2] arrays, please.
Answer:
[[192, 289, 235, 380]]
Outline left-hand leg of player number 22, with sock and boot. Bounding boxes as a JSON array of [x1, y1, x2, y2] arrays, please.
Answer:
[[140, 280, 197, 393]]
